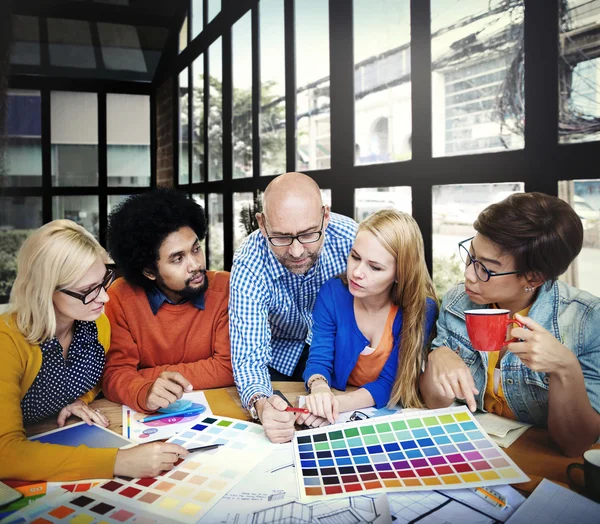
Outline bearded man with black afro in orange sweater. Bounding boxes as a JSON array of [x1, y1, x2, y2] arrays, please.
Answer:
[[103, 189, 233, 413]]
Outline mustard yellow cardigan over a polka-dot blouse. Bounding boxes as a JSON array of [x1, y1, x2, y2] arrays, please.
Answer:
[[0, 314, 118, 481]]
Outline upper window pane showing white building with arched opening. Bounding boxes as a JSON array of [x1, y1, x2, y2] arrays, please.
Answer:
[[354, 0, 412, 164]]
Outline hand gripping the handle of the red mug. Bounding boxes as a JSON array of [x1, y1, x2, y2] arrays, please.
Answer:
[[508, 315, 579, 373]]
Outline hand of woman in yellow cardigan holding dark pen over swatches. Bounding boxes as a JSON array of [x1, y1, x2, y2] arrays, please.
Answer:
[[114, 442, 189, 478]]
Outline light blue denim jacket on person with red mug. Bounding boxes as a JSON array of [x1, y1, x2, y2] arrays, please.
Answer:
[[431, 282, 600, 426]]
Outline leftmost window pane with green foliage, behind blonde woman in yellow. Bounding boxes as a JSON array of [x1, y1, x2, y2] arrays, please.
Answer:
[[0, 196, 42, 303]]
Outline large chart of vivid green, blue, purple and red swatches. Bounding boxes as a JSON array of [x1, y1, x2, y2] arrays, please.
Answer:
[[294, 407, 529, 501]]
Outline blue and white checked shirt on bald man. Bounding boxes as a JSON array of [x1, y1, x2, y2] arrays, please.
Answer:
[[229, 213, 357, 407]]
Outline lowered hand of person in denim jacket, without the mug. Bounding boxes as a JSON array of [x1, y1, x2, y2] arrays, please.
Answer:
[[427, 346, 479, 411]]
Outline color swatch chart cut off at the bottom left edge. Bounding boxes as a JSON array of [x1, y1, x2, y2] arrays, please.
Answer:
[[4, 493, 177, 524]]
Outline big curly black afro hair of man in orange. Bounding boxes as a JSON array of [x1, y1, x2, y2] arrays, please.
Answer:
[[107, 189, 206, 289]]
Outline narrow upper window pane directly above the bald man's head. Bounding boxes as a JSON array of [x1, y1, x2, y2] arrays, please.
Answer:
[[294, 0, 331, 171]]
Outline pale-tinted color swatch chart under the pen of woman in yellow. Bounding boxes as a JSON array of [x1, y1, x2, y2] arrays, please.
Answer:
[[92, 416, 274, 523]]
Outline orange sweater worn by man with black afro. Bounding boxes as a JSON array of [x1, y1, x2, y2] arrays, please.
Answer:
[[102, 271, 233, 413]]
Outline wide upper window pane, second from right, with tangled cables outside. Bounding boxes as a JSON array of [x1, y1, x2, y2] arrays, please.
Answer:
[[431, 0, 525, 157]]
